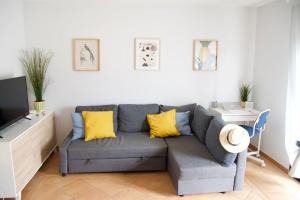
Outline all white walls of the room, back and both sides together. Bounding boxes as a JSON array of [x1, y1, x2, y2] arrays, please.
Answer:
[[0, 0, 290, 166]]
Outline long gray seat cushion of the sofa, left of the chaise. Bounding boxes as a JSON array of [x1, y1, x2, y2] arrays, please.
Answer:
[[68, 132, 167, 160]]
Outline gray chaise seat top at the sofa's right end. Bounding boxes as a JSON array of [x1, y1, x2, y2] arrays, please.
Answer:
[[166, 136, 236, 180]]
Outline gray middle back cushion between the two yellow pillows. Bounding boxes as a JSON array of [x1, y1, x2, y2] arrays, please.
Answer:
[[118, 104, 159, 132]]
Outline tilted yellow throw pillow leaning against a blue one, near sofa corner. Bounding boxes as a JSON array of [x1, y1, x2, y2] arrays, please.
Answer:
[[147, 109, 180, 138]]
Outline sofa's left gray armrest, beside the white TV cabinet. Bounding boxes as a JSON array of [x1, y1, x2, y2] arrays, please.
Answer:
[[59, 131, 73, 175]]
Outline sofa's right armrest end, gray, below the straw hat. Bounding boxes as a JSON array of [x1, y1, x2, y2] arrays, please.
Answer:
[[233, 150, 247, 191]]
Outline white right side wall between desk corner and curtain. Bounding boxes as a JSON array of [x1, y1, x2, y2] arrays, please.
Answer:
[[253, 0, 291, 167]]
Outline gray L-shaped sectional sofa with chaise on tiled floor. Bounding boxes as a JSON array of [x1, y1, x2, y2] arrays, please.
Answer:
[[59, 104, 246, 195]]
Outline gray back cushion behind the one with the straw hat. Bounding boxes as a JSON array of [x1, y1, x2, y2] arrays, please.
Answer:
[[191, 105, 213, 143]]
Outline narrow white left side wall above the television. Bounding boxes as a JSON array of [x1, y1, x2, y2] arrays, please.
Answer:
[[0, 0, 25, 78]]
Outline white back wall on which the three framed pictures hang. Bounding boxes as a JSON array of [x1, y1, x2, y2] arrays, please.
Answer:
[[24, 0, 256, 142]]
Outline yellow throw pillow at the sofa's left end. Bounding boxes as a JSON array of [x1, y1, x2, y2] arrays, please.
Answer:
[[82, 111, 116, 142]]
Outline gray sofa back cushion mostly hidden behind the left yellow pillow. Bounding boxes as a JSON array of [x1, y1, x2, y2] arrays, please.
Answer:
[[75, 104, 118, 132]]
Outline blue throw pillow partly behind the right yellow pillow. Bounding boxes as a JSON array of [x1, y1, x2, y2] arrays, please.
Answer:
[[176, 111, 192, 135]]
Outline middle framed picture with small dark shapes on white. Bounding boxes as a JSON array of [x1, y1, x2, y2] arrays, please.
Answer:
[[135, 38, 160, 71]]
